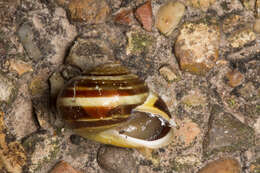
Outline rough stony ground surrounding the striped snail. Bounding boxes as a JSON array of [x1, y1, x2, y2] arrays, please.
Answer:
[[0, 0, 260, 173]]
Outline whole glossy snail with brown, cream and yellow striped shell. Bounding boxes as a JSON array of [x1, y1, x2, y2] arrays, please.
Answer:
[[57, 64, 175, 148]]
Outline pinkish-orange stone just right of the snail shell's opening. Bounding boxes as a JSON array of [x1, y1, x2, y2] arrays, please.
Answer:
[[175, 119, 201, 147]]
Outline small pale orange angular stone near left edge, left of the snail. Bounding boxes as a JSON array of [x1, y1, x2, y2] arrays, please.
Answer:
[[9, 59, 33, 76]]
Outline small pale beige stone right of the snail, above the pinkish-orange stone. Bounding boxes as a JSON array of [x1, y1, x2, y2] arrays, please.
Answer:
[[182, 89, 207, 106]]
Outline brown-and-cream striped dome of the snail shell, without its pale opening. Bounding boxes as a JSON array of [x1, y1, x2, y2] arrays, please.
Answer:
[[57, 65, 149, 129]]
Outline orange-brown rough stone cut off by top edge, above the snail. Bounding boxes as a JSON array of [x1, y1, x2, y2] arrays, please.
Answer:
[[69, 0, 110, 24]]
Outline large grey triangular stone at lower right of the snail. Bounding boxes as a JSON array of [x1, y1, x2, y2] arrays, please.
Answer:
[[204, 105, 254, 154]]
